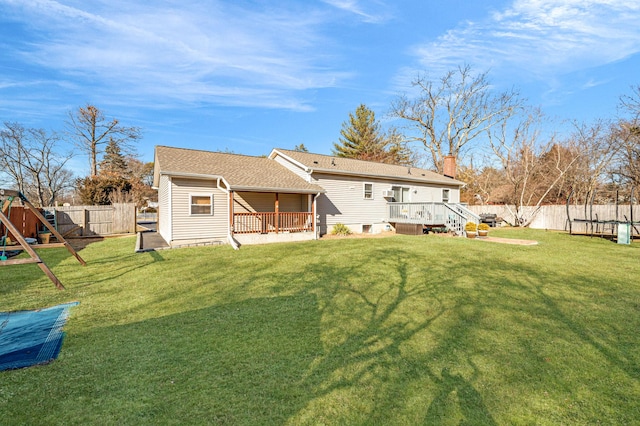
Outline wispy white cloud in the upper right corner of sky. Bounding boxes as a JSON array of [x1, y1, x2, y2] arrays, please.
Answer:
[[404, 0, 640, 80]]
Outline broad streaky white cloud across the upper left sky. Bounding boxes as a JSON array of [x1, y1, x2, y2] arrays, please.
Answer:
[[0, 0, 349, 110]]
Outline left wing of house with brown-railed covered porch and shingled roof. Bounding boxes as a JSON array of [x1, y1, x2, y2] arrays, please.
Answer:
[[153, 146, 324, 246]]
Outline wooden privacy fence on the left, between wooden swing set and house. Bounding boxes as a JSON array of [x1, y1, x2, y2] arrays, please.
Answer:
[[52, 203, 136, 237]]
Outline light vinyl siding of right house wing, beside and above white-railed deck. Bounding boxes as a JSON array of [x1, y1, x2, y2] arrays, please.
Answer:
[[313, 174, 460, 234]]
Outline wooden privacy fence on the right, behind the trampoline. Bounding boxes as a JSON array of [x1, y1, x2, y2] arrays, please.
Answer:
[[467, 204, 640, 235]]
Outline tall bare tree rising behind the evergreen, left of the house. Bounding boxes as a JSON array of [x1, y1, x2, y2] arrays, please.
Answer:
[[67, 104, 142, 176]]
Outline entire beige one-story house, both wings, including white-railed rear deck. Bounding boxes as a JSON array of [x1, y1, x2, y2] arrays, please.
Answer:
[[154, 146, 477, 246]]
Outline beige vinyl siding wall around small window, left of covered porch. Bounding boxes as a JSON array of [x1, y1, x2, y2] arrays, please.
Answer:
[[171, 178, 229, 241]]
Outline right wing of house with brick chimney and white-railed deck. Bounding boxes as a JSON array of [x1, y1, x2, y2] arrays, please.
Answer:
[[269, 149, 477, 234]]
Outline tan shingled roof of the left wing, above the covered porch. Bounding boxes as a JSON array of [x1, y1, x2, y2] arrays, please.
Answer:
[[154, 146, 325, 193]]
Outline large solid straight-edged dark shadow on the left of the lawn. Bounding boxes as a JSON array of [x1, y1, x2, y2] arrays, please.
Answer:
[[5, 295, 322, 424]]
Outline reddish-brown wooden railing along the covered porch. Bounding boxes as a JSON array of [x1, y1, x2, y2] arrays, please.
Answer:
[[233, 212, 313, 234]]
